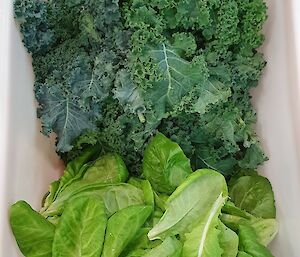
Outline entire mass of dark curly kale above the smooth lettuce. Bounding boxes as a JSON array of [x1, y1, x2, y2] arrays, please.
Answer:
[[14, 0, 267, 175]]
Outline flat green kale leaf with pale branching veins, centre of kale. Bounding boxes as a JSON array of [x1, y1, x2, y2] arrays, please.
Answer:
[[147, 44, 207, 115]]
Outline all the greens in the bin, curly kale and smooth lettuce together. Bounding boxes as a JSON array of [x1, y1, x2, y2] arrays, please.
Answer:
[[10, 0, 278, 254]]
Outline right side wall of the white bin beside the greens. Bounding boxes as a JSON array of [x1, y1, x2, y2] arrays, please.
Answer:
[[254, 0, 300, 254]]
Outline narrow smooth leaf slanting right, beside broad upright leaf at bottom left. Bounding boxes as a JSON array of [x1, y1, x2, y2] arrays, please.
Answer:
[[101, 205, 152, 257]]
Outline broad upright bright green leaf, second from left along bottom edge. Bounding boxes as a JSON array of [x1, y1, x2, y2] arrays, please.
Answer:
[[52, 196, 107, 257]]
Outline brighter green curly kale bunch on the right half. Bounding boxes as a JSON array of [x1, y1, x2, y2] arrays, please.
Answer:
[[117, 0, 266, 174]]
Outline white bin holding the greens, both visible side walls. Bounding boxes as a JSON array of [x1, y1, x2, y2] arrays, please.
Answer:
[[0, 0, 300, 257]]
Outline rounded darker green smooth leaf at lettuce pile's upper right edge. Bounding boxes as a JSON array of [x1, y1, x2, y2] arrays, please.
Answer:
[[229, 173, 276, 219]]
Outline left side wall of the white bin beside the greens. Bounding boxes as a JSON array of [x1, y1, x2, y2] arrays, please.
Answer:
[[0, 0, 60, 257]]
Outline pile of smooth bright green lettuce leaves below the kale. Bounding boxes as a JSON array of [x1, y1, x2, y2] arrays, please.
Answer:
[[10, 133, 278, 257]]
